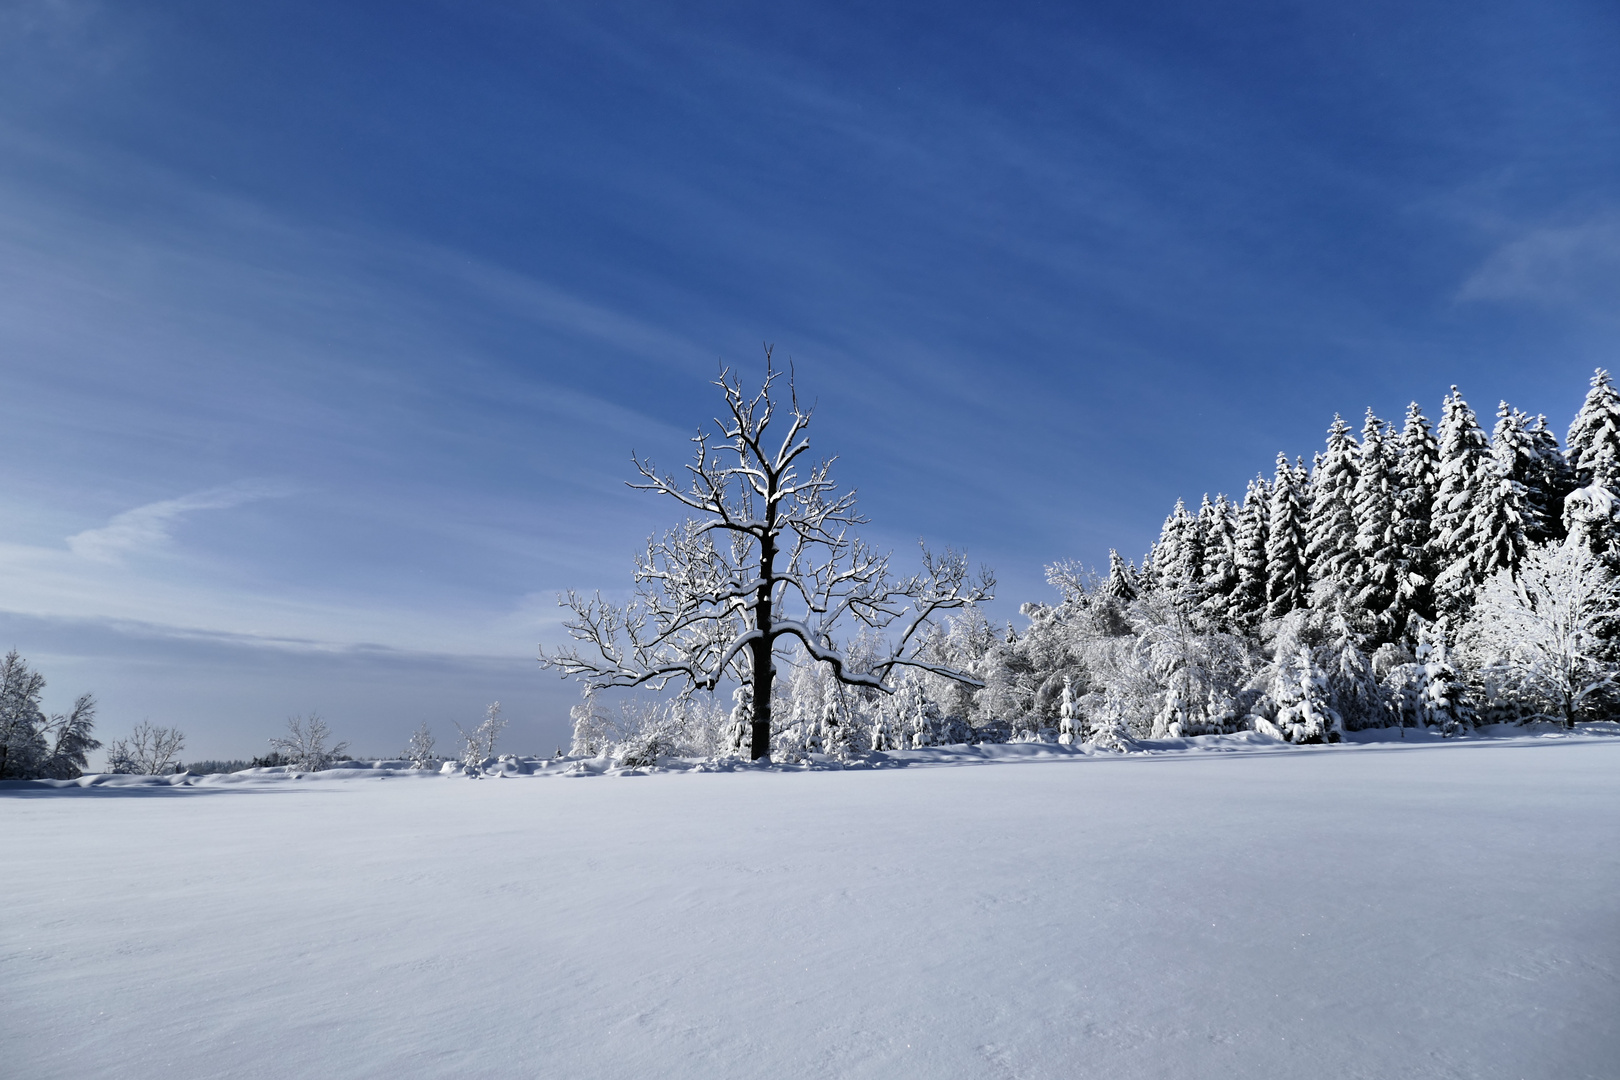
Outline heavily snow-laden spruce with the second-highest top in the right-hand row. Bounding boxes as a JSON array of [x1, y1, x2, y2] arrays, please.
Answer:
[[1430, 387, 1499, 620]]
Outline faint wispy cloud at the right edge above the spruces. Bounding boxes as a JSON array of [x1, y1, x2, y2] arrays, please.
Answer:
[[1458, 210, 1620, 317]]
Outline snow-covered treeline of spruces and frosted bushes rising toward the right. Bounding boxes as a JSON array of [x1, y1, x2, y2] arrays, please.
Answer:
[[573, 371, 1620, 758]]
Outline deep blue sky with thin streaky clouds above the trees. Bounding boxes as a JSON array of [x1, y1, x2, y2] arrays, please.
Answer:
[[0, 0, 1620, 756]]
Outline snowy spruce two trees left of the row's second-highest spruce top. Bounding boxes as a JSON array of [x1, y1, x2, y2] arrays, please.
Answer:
[[1349, 408, 1406, 641]]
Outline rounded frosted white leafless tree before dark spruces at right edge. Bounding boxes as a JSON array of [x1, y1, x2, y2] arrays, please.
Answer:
[[1460, 542, 1620, 727]]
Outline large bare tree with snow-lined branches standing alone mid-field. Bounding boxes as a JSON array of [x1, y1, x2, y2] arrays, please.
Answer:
[[539, 361, 995, 758]]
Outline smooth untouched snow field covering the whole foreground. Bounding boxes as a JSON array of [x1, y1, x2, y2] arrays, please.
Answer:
[[0, 738, 1620, 1080]]
